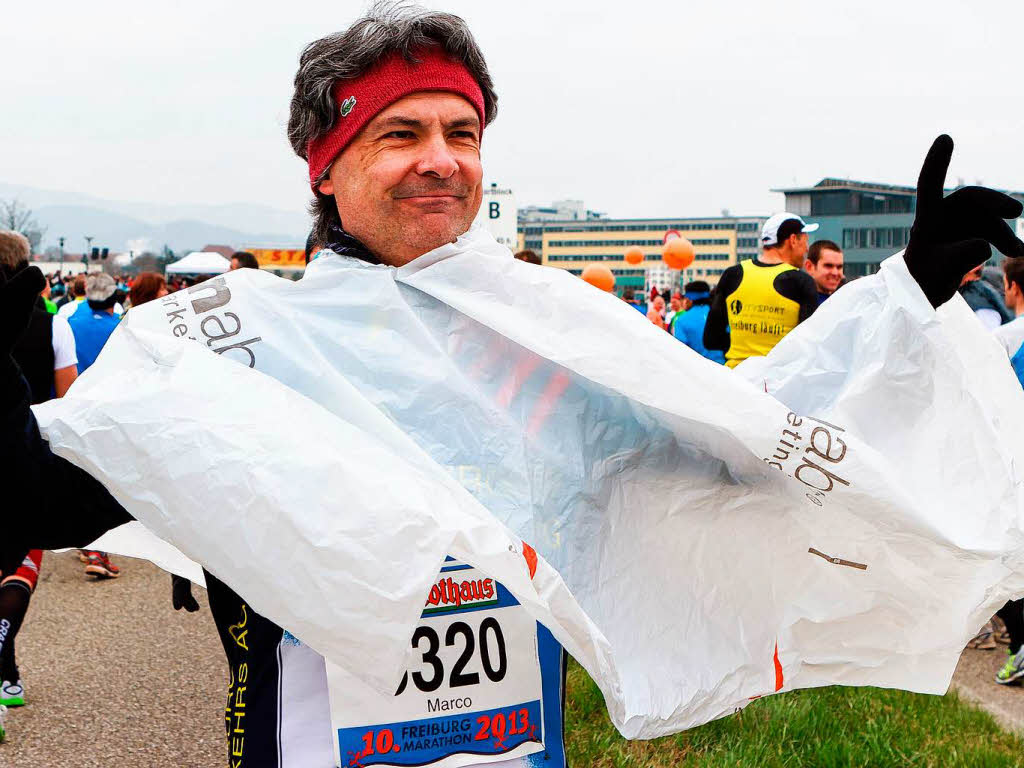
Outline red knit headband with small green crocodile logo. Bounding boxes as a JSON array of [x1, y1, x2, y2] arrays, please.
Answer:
[[306, 47, 484, 190]]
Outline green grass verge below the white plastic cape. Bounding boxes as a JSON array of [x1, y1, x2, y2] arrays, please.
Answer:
[[565, 662, 1024, 768]]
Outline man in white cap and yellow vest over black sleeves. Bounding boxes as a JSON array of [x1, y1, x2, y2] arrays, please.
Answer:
[[703, 212, 818, 368]]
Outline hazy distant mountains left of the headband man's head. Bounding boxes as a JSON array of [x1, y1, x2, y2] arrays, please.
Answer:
[[0, 182, 310, 253]]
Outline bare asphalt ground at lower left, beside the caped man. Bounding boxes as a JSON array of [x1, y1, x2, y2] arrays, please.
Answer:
[[0, 553, 227, 768]]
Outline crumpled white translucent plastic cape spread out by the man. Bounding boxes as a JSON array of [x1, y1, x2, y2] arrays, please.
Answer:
[[29, 229, 1024, 738]]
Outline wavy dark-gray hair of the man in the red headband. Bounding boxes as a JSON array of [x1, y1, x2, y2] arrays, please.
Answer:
[[288, 2, 498, 246]]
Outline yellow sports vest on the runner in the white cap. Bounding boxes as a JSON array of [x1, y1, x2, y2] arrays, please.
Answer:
[[725, 259, 800, 368]]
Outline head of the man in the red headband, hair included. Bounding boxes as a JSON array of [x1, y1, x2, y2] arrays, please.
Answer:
[[288, 13, 498, 266]]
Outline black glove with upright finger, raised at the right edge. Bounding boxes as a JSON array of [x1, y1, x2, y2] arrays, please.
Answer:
[[904, 134, 1024, 307]]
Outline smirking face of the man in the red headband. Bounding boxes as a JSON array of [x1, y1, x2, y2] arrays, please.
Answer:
[[319, 91, 483, 266]]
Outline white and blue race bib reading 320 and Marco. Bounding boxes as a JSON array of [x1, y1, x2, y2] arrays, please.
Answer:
[[328, 558, 544, 768]]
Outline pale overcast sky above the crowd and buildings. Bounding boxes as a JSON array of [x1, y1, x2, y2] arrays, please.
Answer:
[[0, 0, 1024, 216]]
